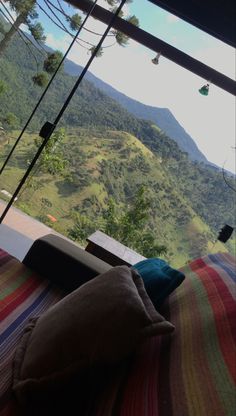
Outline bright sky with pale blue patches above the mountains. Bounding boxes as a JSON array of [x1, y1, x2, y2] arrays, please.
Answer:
[[2, 0, 236, 173]]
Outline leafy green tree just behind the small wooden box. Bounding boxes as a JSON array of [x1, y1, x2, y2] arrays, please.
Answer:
[[68, 186, 167, 257]]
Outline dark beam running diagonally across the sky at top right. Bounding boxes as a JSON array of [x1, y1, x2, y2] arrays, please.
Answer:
[[66, 0, 236, 95]]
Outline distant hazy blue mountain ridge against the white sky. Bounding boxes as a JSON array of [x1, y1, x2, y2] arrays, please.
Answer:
[[65, 60, 208, 163]]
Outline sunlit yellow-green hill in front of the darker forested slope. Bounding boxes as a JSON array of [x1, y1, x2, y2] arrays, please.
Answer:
[[0, 128, 234, 266]]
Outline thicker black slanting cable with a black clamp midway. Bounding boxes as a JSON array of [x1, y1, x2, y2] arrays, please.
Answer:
[[0, 0, 126, 224]]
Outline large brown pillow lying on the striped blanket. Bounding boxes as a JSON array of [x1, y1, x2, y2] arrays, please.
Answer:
[[13, 266, 174, 403]]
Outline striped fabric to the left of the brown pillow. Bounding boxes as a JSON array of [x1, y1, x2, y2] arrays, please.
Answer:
[[0, 250, 63, 416]]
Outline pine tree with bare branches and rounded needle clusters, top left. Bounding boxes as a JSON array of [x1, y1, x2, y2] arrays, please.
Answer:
[[0, 0, 139, 88]]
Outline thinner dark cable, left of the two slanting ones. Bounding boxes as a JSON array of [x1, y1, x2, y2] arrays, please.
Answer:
[[0, 0, 98, 175]]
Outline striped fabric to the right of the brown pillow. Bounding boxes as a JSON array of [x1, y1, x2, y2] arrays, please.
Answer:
[[94, 253, 236, 416]]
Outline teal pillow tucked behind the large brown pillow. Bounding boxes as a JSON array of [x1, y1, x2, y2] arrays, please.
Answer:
[[133, 258, 185, 309]]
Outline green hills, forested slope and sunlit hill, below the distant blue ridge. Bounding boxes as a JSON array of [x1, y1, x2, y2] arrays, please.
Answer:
[[0, 28, 235, 266]]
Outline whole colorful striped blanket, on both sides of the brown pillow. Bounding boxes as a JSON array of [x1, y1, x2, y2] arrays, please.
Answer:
[[0, 251, 236, 416]]
